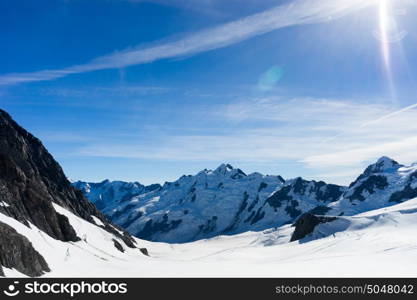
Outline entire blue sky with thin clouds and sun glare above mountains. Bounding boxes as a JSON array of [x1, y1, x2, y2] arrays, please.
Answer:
[[0, 0, 417, 184]]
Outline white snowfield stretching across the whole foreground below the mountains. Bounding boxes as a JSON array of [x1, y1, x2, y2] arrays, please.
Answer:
[[0, 199, 417, 277]]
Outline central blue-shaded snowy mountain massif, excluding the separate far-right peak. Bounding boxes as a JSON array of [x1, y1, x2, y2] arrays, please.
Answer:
[[74, 164, 346, 242]]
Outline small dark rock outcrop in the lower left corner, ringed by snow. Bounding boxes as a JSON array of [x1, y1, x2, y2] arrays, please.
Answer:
[[0, 222, 49, 277]]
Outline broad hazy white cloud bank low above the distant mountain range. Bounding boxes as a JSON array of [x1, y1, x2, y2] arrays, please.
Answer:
[[71, 97, 417, 183]]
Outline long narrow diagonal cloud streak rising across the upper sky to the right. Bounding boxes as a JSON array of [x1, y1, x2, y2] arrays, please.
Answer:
[[0, 0, 378, 85]]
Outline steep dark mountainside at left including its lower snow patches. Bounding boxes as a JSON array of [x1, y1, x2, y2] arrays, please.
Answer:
[[0, 110, 146, 276]]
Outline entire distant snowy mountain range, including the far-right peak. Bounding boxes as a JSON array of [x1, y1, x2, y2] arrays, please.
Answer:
[[73, 157, 417, 243]]
